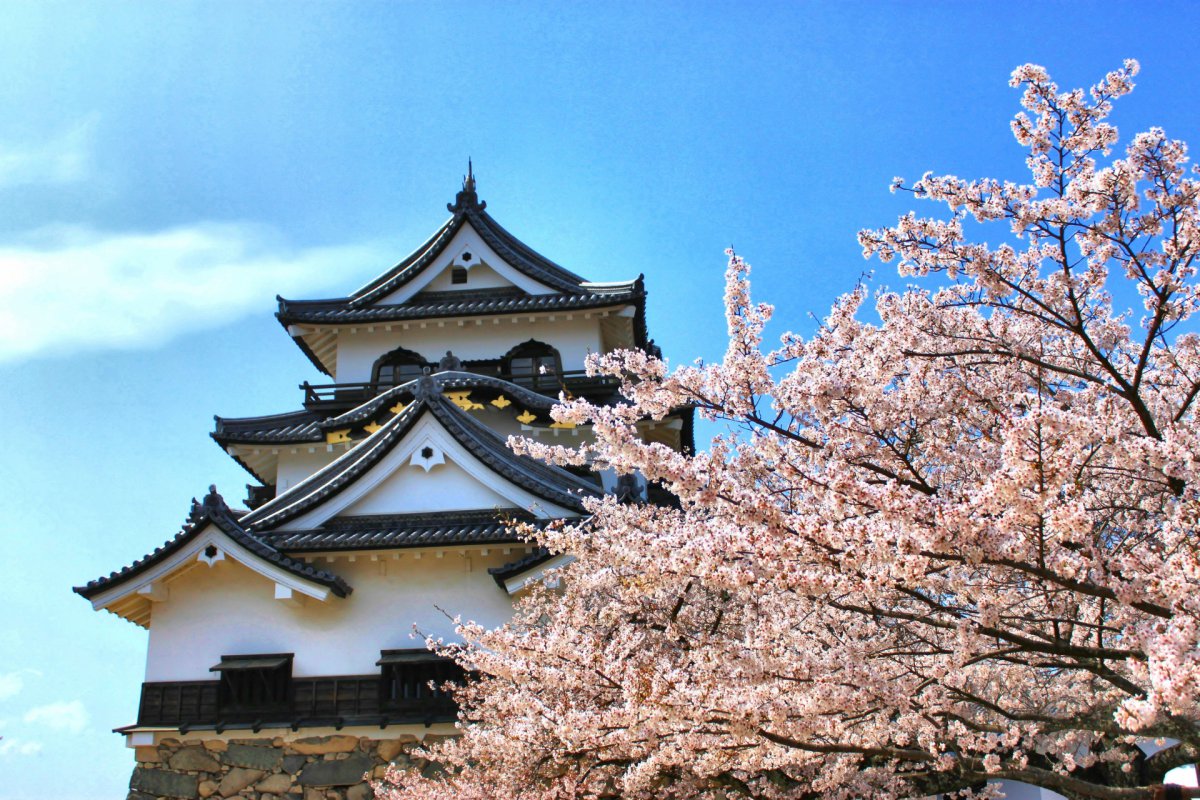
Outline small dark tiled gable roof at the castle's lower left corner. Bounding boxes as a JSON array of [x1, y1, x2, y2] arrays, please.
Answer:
[[74, 487, 353, 600]]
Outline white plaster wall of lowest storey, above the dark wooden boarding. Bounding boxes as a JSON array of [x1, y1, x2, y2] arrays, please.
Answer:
[[145, 549, 524, 681]]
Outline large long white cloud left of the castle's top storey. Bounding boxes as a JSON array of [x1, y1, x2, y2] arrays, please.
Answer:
[[0, 224, 390, 362]]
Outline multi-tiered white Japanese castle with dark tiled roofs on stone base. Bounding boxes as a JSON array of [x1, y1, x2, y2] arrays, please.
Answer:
[[76, 170, 692, 800]]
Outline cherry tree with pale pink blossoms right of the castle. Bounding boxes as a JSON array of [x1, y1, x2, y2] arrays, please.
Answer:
[[379, 61, 1200, 800]]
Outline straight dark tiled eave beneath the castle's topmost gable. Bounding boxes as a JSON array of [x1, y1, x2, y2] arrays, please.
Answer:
[[276, 286, 646, 325]]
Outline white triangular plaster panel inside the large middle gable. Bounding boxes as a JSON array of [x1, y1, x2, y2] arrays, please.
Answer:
[[341, 463, 515, 516]]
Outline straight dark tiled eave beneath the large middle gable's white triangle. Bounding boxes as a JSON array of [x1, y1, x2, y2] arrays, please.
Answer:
[[260, 511, 545, 553]]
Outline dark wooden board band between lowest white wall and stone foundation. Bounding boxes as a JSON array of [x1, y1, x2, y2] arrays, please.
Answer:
[[138, 674, 457, 732]]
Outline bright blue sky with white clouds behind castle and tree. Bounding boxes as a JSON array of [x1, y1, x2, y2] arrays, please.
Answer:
[[0, 2, 1200, 800]]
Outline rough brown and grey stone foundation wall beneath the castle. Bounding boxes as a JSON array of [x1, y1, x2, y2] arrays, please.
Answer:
[[126, 735, 439, 800]]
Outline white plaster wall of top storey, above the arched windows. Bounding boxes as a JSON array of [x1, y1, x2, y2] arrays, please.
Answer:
[[336, 312, 601, 384]]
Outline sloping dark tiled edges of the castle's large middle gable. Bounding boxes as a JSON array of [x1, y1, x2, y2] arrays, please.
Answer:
[[242, 375, 600, 531]]
